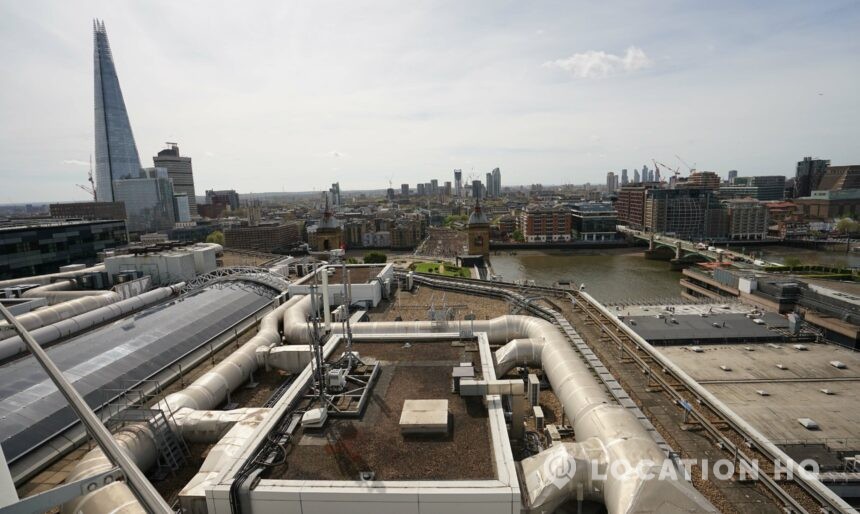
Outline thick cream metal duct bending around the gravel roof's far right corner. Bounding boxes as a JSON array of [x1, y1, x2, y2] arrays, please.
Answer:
[[284, 310, 717, 514]]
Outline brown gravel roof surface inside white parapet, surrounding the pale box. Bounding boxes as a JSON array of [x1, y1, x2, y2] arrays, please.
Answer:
[[269, 341, 496, 480]]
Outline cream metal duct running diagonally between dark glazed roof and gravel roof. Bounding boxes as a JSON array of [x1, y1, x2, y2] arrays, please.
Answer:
[[62, 297, 302, 514]]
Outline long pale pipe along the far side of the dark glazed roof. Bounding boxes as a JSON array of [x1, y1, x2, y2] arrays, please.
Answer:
[[0, 282, 185, 360]]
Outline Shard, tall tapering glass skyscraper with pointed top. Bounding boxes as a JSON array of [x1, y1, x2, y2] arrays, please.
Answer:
[[93, 20, 140, 202]]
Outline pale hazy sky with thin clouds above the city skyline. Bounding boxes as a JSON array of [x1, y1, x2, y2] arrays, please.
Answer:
[[0, 0, 860, 203]]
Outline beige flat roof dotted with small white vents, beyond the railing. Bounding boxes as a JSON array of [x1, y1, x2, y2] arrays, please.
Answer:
[[658, 343, 860, 450]]
